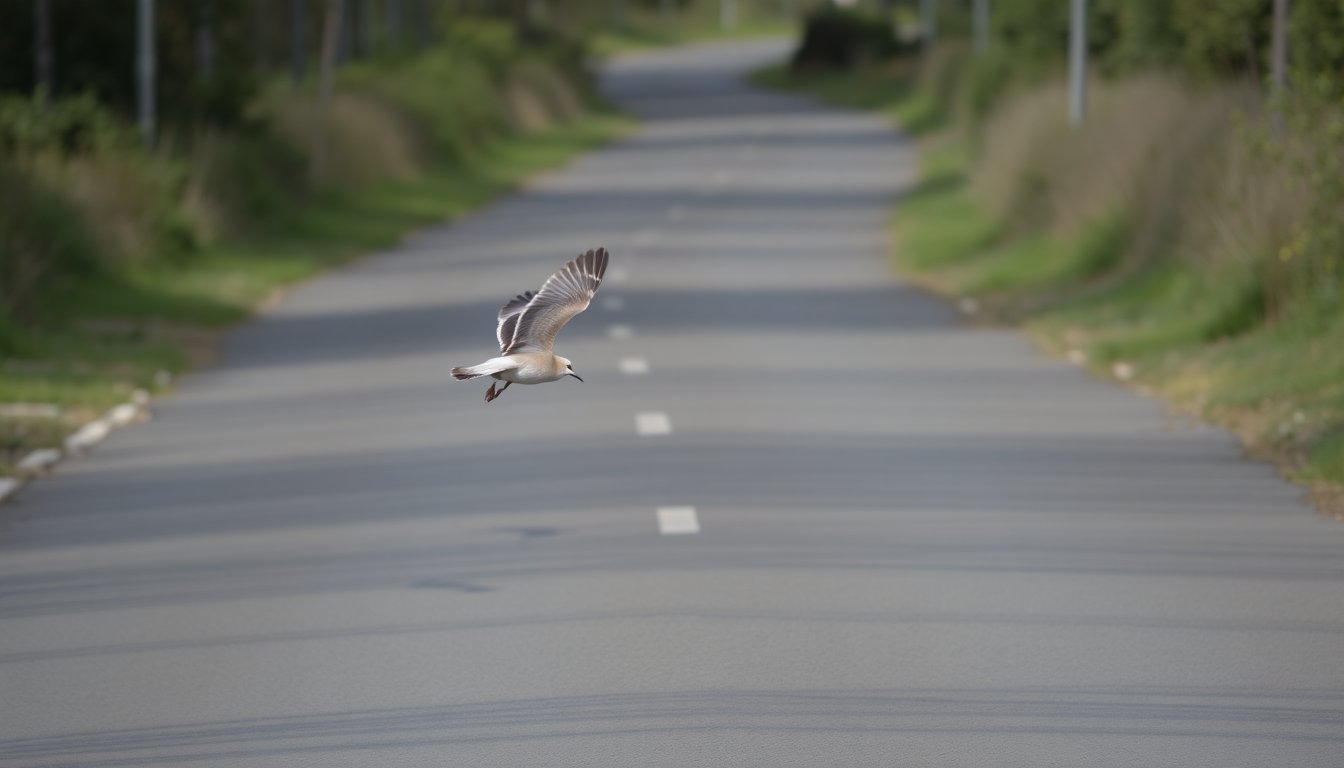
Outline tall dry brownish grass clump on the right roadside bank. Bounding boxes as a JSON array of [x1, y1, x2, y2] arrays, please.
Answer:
[[972, 74, 1309, 291]]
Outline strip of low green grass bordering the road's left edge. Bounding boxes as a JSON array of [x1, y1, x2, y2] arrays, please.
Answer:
[[0, 106, 630, 473]]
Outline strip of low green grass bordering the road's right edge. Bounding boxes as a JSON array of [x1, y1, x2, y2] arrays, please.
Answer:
[[755, 57, 1344, 514]]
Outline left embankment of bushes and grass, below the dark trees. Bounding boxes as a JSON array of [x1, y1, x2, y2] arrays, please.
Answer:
[[0, 22, 629, 475]]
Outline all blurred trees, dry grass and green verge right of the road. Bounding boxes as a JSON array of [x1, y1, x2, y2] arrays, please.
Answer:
[[779, 0, 1344, 497]]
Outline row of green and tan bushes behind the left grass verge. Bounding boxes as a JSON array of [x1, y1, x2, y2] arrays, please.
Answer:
[[0, 13, 590, 344]]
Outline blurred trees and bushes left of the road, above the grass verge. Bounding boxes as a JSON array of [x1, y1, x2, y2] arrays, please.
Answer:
[[0, 0, 794, 342]]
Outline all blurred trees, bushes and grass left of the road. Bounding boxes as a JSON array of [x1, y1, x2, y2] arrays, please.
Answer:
[[0, 0, 790, 473]]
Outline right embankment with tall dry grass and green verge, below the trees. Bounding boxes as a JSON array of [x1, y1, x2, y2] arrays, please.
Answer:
[[758, 48, 1344, 516]]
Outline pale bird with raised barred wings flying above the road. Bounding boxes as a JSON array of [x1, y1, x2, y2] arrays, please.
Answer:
[[453, 247, 606, 402]]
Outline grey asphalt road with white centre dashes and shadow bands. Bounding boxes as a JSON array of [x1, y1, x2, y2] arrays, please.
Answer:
[[0, 44, 1344, 768]]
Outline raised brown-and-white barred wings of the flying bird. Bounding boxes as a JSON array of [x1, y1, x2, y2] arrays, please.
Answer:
[[500, 247, 606, 355]]
